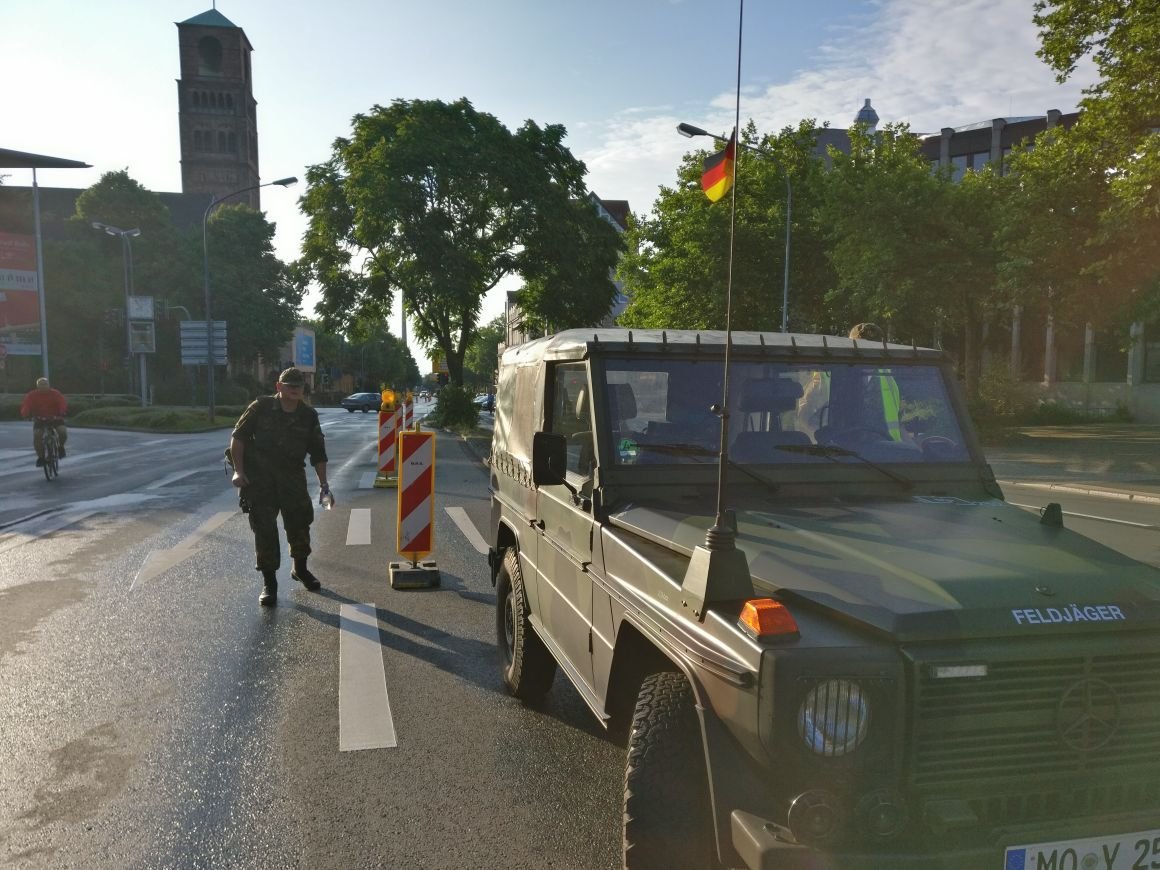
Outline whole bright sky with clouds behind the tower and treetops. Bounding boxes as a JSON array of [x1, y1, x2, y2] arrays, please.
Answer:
[[0, 0, 1090, 368]]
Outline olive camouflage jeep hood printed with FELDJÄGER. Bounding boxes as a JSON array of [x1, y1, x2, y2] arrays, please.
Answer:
[[610, 496, 1160, 640]]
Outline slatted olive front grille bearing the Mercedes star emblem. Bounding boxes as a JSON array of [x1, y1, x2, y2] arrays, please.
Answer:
[[909, 653, 1160, 798]]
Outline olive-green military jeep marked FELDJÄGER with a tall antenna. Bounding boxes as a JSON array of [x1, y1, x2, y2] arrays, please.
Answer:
[[490, 329, 1160, 870]]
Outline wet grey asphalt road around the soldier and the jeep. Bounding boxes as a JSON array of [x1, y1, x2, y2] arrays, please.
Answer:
[[0, 409, 1160, 870]]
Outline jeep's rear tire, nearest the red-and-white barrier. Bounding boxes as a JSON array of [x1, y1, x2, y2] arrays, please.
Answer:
[[495, 546, 556, 701]]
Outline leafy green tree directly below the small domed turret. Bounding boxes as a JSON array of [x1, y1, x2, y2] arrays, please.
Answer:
[[820, 124, 1007, 392]]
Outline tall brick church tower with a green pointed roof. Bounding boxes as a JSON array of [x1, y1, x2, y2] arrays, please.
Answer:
[[177, 7, 260, 209]]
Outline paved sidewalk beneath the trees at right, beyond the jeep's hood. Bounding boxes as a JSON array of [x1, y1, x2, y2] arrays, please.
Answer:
[[985, 423, 1160, 500]]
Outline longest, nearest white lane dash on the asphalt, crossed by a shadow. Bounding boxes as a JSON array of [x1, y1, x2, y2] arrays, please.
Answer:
[[339, 603, 399, 752]]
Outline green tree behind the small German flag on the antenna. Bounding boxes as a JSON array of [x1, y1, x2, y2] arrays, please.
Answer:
[[618, 121, 832, 329]]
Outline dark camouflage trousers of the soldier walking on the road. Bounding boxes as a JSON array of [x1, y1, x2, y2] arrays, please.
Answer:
[[241, 467, 314, 572]]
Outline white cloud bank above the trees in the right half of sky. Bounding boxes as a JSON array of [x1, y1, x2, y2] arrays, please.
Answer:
[[578, 0, 1094, 219]]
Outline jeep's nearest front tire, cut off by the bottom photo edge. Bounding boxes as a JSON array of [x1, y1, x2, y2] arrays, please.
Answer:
[[624, 672, 717, 870]]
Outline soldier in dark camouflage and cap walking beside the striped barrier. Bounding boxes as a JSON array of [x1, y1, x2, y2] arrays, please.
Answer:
[[230, 367, 331, 607]]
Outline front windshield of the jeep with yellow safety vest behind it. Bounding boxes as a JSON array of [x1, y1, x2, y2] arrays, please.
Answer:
[[604, 358, 970, 465]]
